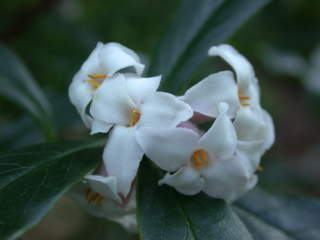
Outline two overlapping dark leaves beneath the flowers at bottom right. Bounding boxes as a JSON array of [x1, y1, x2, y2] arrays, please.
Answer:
[[137, 161, 320, 240]]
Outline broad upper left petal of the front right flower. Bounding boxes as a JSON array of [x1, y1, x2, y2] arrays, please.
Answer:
[[137, 127, 199, 171]]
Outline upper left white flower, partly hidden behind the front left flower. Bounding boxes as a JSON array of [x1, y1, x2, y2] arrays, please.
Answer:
[[69, 42, 144, 128]]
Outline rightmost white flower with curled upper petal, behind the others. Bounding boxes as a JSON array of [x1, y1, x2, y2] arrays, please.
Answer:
[[181, 45, 275, 168]]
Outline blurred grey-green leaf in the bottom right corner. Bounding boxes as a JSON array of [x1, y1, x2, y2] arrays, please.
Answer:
[[235, 189, 320, 240]]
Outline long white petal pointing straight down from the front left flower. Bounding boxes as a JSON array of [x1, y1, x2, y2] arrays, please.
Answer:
[[103, 126, 143, 196]]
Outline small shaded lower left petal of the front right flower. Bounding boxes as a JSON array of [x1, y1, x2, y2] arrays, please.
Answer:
[[159, 167, 204, 195]]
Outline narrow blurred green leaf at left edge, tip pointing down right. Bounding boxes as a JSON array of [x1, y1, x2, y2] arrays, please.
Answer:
[[0, 45, 54, 140]]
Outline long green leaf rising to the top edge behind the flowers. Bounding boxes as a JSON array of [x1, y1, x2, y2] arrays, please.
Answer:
[[149, 0, 269, 92]]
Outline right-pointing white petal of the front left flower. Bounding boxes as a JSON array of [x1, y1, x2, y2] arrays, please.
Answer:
[[139, 92, 193, 128]]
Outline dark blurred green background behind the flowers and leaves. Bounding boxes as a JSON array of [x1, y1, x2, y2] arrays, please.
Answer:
[[0, 0, 320, 240]]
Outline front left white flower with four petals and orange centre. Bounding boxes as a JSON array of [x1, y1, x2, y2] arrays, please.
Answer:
[[90, 73, 193, 196]]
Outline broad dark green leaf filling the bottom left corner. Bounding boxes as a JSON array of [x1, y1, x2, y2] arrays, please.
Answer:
[[0, 140, 102, 239]]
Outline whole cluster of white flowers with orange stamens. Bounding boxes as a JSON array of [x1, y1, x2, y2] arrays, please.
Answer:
[[69, 43, 274, 230]]
